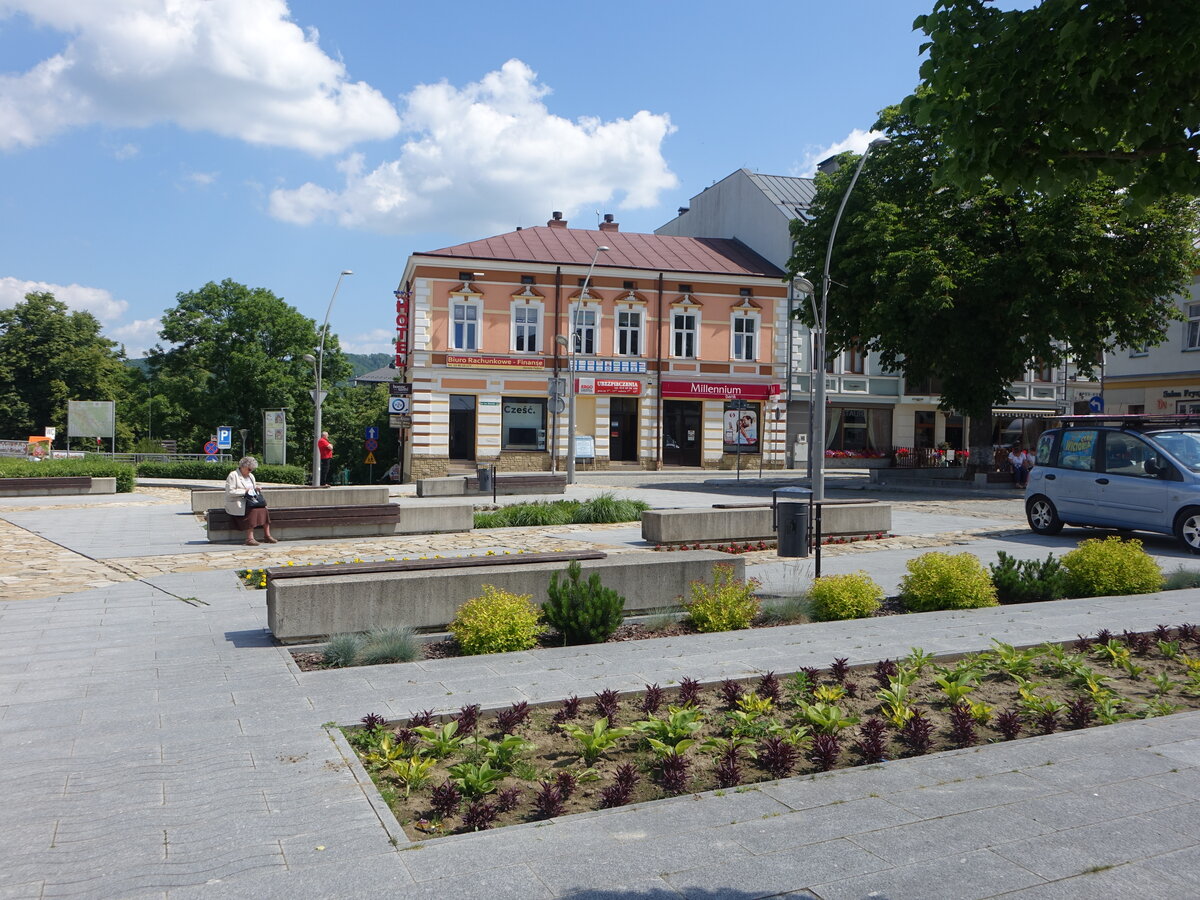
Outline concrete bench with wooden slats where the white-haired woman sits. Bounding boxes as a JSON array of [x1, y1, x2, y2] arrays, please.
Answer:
[[204, 500, 475, 544]]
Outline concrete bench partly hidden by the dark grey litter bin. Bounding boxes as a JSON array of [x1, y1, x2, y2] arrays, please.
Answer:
[[642, 500, 892, 545]]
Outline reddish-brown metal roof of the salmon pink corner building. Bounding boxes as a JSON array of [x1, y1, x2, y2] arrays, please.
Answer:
[[413, 226, 784, 278]]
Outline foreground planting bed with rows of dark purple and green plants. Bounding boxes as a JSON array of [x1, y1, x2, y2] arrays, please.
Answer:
[[343, 625, 1200, 840]]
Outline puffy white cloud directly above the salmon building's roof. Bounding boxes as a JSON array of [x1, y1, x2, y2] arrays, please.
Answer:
[[270, 59, 678, 234]]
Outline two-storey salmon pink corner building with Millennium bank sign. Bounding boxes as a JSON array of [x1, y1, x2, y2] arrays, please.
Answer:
[[396, 214, 788, 479]]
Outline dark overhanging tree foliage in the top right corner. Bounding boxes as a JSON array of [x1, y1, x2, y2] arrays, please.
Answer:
[[905, 0, 1200, 202]]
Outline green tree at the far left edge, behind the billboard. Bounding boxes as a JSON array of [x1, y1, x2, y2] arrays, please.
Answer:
[[0, 292, 128, 439]]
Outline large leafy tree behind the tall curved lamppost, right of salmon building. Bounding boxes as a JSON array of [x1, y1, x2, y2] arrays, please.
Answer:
[[790, 107, 1198, 461]]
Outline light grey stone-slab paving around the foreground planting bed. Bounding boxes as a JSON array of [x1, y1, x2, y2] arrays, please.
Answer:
[[0, 489, 1200, 900]]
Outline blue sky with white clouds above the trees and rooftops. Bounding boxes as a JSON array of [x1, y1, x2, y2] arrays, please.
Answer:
[[0, 0, 964, 356]]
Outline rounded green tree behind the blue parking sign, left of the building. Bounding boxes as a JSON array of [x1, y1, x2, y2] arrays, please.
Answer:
[[149, 278, 350, 466]]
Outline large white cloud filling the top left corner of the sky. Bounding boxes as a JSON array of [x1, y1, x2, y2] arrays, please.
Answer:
[[0, 0, 400, 154]]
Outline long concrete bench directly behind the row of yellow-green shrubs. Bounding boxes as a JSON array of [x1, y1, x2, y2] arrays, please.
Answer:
[[266, 550, 745, 643]]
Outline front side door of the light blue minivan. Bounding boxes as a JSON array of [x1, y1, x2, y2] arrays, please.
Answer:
[[1094, 431, 1170, 530]]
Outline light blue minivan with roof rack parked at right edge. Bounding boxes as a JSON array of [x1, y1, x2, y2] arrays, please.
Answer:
[[1025, 415, 1200, 553]]
